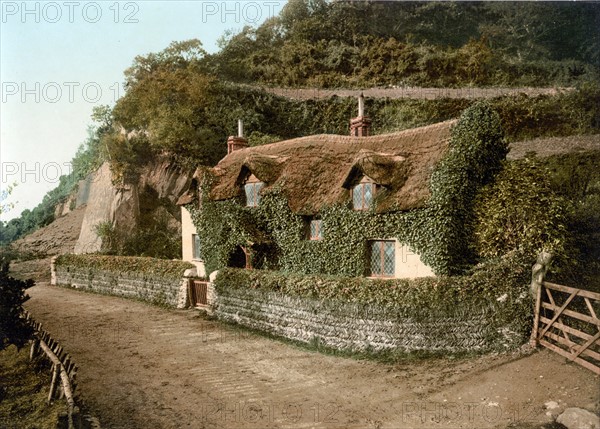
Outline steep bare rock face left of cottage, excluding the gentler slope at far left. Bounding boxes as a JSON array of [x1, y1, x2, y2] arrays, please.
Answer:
[[74, 158, 193, 253]]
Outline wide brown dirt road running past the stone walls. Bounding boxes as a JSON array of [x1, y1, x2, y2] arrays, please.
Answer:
[[19, 283, 600, 429]]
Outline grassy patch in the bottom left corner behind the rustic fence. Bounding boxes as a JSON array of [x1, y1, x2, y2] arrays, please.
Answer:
[[0, 346, 66, 429]]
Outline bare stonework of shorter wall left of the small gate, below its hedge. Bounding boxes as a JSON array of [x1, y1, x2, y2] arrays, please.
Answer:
[[51, 257, 196, 308]]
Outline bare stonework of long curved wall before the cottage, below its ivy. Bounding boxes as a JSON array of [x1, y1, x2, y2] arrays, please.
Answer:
[[214, 288, 519, 352]]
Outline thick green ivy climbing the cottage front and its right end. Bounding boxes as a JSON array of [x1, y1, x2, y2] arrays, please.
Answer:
[[186, 104, 507, 277]]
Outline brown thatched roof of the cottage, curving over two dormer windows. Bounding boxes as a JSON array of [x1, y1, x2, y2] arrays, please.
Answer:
[[210, 121, 455, 215]]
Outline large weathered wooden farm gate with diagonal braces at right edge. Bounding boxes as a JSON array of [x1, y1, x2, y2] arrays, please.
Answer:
[[531, 281, 600, 375]]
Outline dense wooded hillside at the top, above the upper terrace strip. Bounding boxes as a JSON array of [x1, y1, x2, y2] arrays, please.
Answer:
[[207, 0, 600, 87]]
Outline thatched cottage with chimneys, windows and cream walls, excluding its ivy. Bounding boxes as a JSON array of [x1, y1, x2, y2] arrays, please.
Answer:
[[179, 97, 454, 278]]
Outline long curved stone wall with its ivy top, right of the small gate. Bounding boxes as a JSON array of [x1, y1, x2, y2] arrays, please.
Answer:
[[215, 254, 531, 353]]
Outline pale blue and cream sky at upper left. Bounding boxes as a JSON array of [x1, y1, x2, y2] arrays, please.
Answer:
[[0, 0, 286, 221]]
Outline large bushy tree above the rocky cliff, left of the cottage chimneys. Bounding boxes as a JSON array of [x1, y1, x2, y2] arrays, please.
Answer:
[[112, 40, 223, 164]]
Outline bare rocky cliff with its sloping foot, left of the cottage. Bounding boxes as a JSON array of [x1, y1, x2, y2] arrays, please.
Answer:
[[12, 158, 193, 256]]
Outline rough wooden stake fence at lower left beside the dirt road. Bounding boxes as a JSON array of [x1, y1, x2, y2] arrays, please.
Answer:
[[25, 312, 82, 429]]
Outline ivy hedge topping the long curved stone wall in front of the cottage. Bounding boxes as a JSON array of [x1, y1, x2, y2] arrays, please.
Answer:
[[215, 254, 533, 340]]
